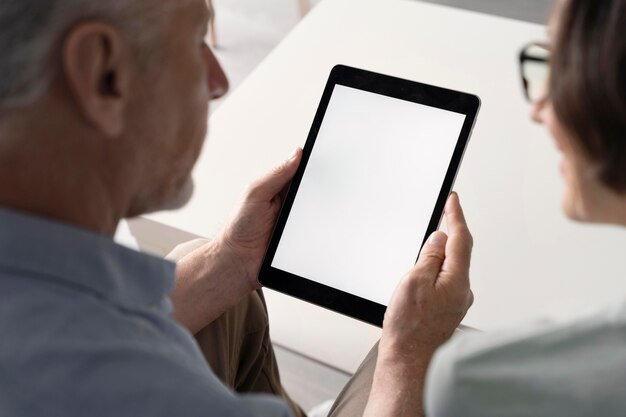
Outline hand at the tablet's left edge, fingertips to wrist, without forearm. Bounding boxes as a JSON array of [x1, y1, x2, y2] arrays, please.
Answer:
[[220, 148, 302, 289]]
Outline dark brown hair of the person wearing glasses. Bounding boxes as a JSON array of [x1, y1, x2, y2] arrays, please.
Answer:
[[550, 0, 626, 193]]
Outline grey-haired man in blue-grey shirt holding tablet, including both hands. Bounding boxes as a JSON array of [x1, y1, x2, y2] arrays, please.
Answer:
[[0, 0, 472, 417]]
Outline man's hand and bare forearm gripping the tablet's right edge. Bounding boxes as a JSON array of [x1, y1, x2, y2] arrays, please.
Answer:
[[365, 193, 474, 417]]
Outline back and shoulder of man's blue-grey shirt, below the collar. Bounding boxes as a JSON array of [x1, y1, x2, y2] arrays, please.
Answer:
[[0, 277, 287, 417]]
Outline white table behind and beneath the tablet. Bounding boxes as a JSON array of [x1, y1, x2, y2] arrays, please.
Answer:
[[131, 0, 626, 370]]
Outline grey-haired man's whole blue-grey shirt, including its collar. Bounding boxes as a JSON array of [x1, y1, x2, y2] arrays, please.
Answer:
[[0, 209, 291, 417]]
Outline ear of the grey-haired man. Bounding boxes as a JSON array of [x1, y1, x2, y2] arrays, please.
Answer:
[[62, 22, 133, 137]]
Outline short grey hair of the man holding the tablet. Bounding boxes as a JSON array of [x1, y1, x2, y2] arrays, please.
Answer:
[[0, 0, 167, 108]]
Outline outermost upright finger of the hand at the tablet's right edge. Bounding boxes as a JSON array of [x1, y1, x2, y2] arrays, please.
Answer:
[[445, 193, 473, 276]]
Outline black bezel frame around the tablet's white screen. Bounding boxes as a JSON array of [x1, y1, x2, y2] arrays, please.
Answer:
[[259, 65, 480, 327]]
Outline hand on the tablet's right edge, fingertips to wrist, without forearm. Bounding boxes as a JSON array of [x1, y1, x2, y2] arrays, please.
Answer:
[[381, 193, 474, 363]]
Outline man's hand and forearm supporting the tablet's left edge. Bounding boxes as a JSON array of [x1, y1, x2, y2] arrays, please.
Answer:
[[169, 148, 302, 334]]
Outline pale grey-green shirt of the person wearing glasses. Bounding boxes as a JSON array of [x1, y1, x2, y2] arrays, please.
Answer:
[[425, 305, 626, 417]]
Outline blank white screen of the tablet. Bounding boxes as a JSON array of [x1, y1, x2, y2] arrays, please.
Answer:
[[272, 85, 466, 305]]
